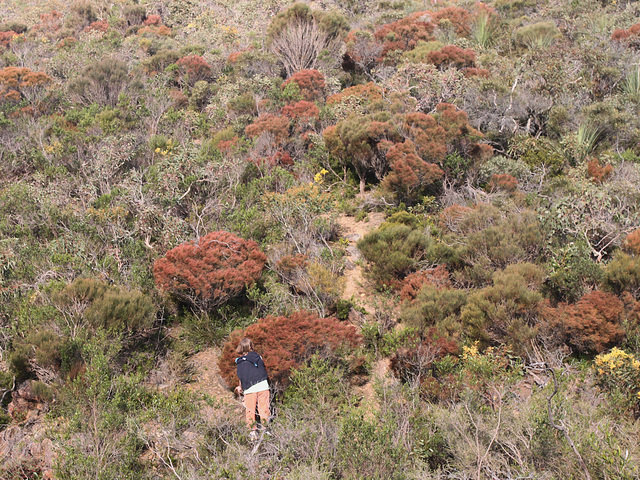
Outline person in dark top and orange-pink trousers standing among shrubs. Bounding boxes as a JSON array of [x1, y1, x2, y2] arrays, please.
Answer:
[[235, 337, 270, 440]]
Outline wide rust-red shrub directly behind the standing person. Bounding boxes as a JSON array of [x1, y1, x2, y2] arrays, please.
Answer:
[[218, 311, 362, 390]]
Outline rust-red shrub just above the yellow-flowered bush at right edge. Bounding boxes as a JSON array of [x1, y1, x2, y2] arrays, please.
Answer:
[[540, 290, 624, 353]]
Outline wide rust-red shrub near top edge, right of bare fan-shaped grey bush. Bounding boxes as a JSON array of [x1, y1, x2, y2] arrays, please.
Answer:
[[374, 12, 434, 61]]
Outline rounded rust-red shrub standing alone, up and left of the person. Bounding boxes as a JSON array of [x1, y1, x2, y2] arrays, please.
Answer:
[[153, 231, 267, 311]]
